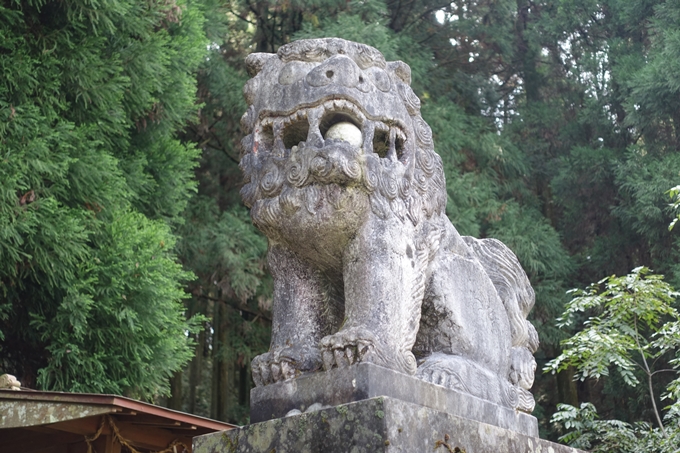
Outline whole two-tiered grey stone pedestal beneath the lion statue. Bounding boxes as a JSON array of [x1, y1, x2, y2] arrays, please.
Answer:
[[194, 363, 577, 453]]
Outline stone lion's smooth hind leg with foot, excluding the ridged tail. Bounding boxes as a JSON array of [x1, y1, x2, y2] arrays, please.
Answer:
[[414, 249, 517, 408]]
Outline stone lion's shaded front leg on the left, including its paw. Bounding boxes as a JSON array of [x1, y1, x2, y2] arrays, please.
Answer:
[[252, 242, 339, 386]]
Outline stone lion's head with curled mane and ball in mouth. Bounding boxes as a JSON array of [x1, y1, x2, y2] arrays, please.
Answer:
[[241, 38, 446, 233]]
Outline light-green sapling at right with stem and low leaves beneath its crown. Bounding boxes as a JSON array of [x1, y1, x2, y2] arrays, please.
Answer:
[[543, 267, 680, 452]]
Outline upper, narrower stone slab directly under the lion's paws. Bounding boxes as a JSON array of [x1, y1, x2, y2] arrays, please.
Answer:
[[250, 363, 538, 437]]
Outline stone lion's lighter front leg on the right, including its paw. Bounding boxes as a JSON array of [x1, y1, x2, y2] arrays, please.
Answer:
[[321, 217, 422, 374]]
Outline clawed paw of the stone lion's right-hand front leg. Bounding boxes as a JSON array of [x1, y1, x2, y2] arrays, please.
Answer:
[[320, 328, 376, 370]]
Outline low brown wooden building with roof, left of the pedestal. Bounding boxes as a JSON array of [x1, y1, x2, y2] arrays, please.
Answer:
[[0, 390, 236, 453]]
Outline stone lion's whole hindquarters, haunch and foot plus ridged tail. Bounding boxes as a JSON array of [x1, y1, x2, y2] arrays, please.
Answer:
[[414, 222, 537, 412]]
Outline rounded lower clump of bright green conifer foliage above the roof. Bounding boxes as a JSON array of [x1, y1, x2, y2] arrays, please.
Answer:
[[29, 212, 198, 397]]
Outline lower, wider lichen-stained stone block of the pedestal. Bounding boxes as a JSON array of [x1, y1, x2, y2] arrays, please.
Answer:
[[193, 398, 578, 453]]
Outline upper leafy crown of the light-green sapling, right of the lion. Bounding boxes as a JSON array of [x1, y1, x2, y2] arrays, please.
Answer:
[[544, 267, 680, 386]]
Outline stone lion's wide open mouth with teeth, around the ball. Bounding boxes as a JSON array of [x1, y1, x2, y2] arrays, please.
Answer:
[[255, 99, 406, 160]]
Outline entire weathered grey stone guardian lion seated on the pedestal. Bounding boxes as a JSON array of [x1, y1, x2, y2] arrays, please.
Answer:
[[241, 38, 538, 412]]
